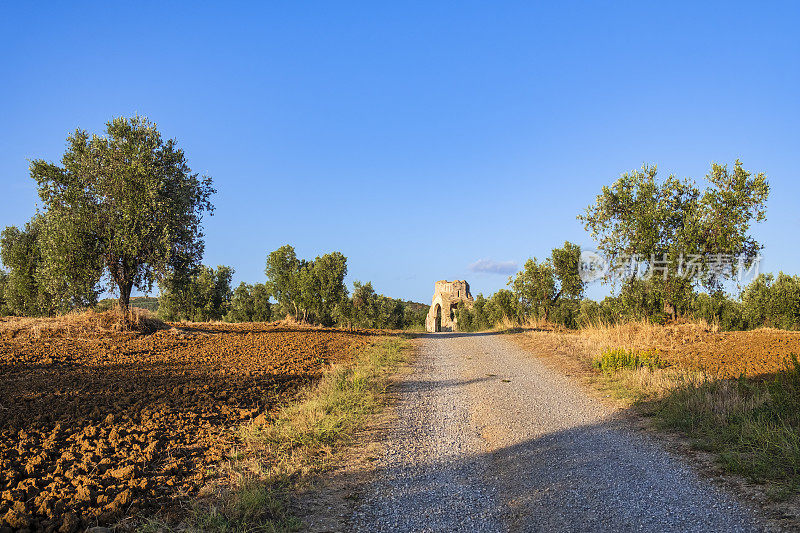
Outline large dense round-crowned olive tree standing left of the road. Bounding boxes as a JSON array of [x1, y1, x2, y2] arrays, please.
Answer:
[[31, 116, 215, 310]]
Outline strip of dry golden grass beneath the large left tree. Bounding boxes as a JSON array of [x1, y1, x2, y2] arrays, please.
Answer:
[[0, 308, 169, 338]]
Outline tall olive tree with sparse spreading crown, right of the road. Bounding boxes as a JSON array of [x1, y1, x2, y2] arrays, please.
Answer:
[[578, 160, 769, 317]]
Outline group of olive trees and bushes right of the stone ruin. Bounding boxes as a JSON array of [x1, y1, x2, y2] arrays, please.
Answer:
[[459, 161, 800, 330]]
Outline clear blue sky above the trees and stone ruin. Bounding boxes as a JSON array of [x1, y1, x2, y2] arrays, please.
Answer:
[[0, 2, 800, 302]]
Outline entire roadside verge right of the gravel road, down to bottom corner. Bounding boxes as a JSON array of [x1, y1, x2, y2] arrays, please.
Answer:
[[508, 324, 800, 530]]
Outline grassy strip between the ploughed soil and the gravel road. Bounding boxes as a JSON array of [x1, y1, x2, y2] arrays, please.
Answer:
[[138, 337, 411, 533]]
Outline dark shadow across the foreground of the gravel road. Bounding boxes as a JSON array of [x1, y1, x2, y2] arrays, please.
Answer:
[[328, 421, 757, 532]]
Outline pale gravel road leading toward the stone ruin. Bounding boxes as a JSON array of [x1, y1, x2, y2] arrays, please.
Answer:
[[351, 334, 761, 532]]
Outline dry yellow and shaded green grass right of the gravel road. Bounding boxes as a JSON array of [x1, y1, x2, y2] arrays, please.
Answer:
[[514, 323, 800, 505]]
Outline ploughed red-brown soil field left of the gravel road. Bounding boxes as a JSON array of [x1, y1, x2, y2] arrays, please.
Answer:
[[0, 318, 369, 531]]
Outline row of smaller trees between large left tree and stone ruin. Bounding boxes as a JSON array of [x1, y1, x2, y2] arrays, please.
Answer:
[[148, 245, 427, 329]]
